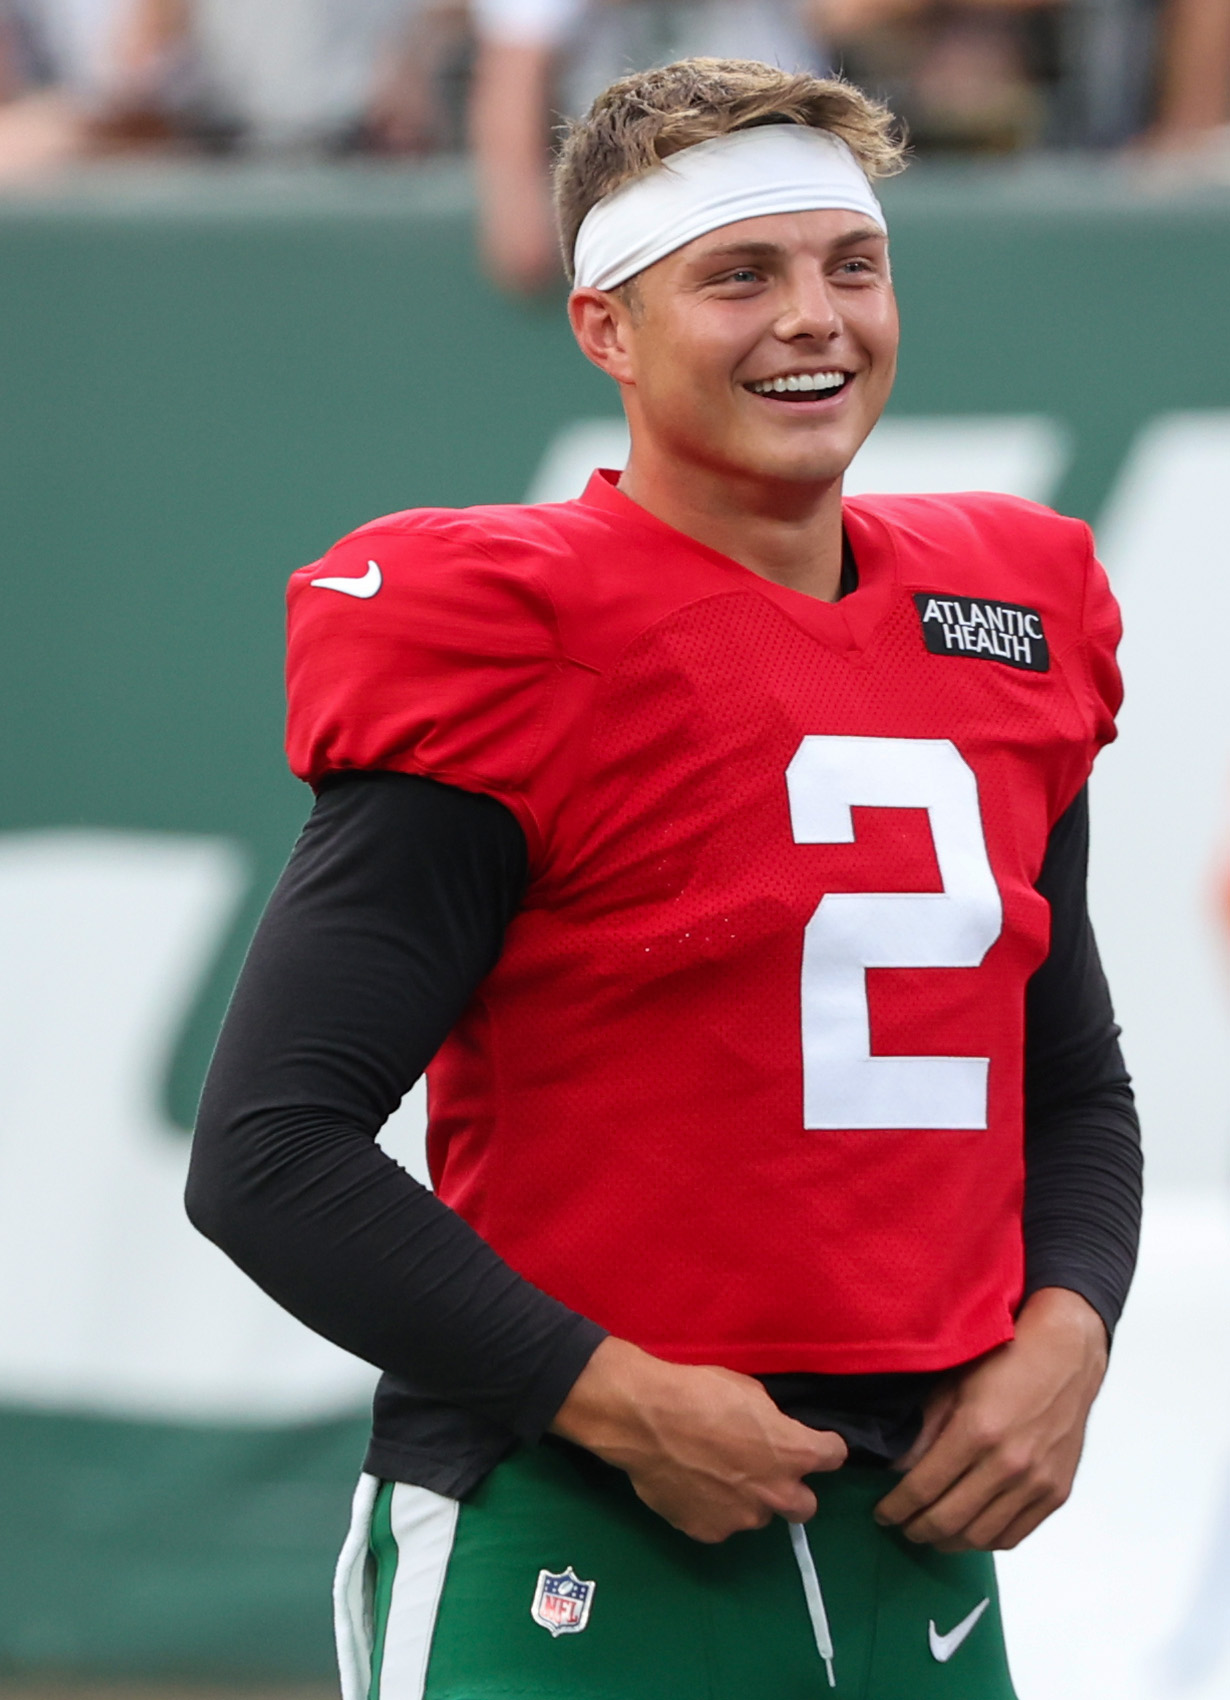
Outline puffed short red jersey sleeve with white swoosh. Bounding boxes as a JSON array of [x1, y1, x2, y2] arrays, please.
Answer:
[[287, 515, 559, 863]]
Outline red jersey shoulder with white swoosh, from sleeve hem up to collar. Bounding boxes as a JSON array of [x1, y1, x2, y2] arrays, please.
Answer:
[[287, 491, 730, 855]]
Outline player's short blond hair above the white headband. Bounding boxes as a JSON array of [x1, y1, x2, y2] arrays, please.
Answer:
[[554, 60, 906, 279]]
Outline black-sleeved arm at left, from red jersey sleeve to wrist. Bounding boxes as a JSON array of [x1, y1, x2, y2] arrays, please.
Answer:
[[187, 775, 603, 1438]]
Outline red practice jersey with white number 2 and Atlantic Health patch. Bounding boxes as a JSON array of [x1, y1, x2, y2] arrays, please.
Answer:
[[289, 474, 1120, 1374]]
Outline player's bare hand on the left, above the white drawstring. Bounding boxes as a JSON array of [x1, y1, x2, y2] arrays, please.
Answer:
[[550, 1338, 846, 1542]]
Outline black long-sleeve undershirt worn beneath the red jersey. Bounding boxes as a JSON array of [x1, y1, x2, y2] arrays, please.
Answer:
[[187, 774, 1140, 1494]]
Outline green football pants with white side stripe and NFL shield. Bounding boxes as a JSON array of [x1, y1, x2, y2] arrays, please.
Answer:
[[336, 1442, 1014, 1700]]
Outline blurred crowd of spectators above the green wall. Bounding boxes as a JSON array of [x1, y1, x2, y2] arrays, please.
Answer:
[[0, 0, 1230, 289]]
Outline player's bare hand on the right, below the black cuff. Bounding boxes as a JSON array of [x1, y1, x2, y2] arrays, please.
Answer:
[[875, 1287, 1108, 1552]]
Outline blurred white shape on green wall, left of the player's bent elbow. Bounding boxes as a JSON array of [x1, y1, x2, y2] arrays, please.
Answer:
[[0, 831, 394, 1420]]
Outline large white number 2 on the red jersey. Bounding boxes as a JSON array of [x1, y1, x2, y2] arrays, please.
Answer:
[[787, 736, 1004, 1129]]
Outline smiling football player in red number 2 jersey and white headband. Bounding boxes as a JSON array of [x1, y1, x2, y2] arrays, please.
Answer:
[[189, 60, 1140, 1700]]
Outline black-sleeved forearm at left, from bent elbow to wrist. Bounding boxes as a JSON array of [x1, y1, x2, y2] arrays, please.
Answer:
[[187, 1100, 603, 1440]]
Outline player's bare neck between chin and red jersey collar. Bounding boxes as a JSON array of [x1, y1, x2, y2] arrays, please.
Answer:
[[618, 447, 841, 602]]
